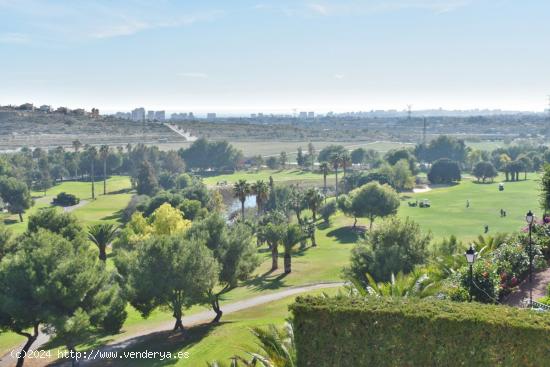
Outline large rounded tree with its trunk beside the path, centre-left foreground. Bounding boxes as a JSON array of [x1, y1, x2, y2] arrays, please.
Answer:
[[123, 236, 219, 331]]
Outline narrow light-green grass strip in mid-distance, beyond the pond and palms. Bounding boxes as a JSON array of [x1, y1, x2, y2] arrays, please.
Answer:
[[203, 169, 341, 186]]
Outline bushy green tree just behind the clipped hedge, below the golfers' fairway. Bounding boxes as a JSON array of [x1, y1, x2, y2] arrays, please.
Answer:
[[345, 217, 431, 287]]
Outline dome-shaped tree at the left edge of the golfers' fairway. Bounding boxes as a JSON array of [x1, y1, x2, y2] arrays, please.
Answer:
[[339, 182, 400, 230]]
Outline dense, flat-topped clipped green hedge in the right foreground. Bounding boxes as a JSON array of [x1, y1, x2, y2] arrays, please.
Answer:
[[290, 296, 550, 367]]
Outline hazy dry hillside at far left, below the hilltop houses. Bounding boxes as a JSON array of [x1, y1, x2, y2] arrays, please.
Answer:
[[0, 109, 185, 150]]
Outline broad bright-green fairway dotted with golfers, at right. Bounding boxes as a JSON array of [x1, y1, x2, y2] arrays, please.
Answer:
[[398, 174, 542, 241]]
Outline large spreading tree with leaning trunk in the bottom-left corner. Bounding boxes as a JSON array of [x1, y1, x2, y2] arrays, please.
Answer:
[[0, 229, 126, 366]]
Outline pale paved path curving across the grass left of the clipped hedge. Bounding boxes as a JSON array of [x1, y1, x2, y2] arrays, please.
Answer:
[[0, 282, 344, 367]]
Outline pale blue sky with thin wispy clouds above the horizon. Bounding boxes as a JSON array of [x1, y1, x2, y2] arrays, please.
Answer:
[[0, 0, 550, 113]]
